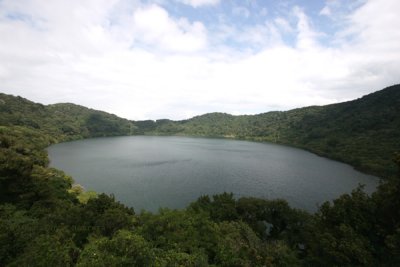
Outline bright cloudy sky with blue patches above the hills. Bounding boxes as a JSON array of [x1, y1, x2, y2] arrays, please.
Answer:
[[0, 0, 400, 120]]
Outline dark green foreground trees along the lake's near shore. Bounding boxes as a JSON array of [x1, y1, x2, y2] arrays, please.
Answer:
[[0, 126, 400, 266]]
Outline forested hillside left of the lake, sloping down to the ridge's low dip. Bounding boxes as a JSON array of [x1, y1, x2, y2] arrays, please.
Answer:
[[0, 94, 133, 141]]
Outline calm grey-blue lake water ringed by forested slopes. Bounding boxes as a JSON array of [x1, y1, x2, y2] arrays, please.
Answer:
[[48, 136, 378, 211]]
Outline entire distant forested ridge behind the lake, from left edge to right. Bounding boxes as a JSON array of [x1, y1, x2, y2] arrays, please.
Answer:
[[0, 85, 400, 177]]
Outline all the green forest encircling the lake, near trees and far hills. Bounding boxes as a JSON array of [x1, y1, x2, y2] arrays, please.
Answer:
[[0, 86, 400, 266]]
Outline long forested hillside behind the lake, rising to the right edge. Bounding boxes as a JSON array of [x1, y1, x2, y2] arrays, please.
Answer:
[[135, 85, 400, 177]]
